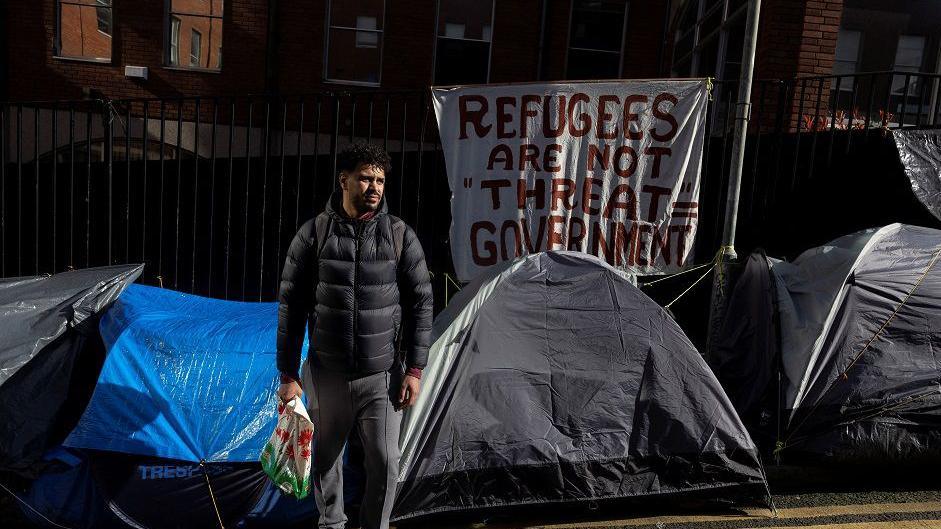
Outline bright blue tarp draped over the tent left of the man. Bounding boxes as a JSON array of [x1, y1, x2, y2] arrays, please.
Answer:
[[65, 285, 307, 462]]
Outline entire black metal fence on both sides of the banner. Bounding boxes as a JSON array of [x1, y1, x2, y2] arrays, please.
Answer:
[[0, 72, 941, 308]]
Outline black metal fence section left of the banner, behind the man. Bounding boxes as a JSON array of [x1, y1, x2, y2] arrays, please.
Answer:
[[0, 92, 449, 300]]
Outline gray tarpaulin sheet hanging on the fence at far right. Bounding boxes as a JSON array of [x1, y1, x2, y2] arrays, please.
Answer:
[[892, 129, 941, 219]]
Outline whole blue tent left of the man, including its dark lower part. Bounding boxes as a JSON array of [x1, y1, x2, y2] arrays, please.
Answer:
[[30, 285, 359, 528]]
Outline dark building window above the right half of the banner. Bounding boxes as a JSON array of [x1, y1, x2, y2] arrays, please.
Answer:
[[566, 0, 627, 79]]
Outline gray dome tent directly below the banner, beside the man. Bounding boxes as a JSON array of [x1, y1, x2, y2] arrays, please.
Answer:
[[395, 252, 766, 520]]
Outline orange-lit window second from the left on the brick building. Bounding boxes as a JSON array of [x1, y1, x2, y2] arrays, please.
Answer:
[[166, 0, 224, 70]]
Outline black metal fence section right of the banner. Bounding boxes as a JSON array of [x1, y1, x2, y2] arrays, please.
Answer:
[[697, 72, 941, 259]]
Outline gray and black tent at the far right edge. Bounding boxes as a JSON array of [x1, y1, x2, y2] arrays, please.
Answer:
[[719, 224, 941, 462]]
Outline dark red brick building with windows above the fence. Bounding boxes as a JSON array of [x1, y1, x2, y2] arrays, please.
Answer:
[[0, 0, 928, 100]]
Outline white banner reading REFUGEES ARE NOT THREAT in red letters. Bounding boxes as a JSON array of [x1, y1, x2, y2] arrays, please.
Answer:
[[432, 79, 708, 281]]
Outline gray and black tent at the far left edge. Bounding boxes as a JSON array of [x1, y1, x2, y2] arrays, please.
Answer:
[[0, 265, 143, 477]]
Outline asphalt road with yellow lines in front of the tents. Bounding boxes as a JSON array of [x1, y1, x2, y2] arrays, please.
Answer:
[[0, 467, 941, 529]]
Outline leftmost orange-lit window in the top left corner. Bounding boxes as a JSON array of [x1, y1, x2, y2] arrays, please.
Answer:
[[56, 0, 114, 62]]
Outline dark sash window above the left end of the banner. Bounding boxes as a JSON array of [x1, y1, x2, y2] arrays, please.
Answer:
[[434, 0, 494, 85]]
